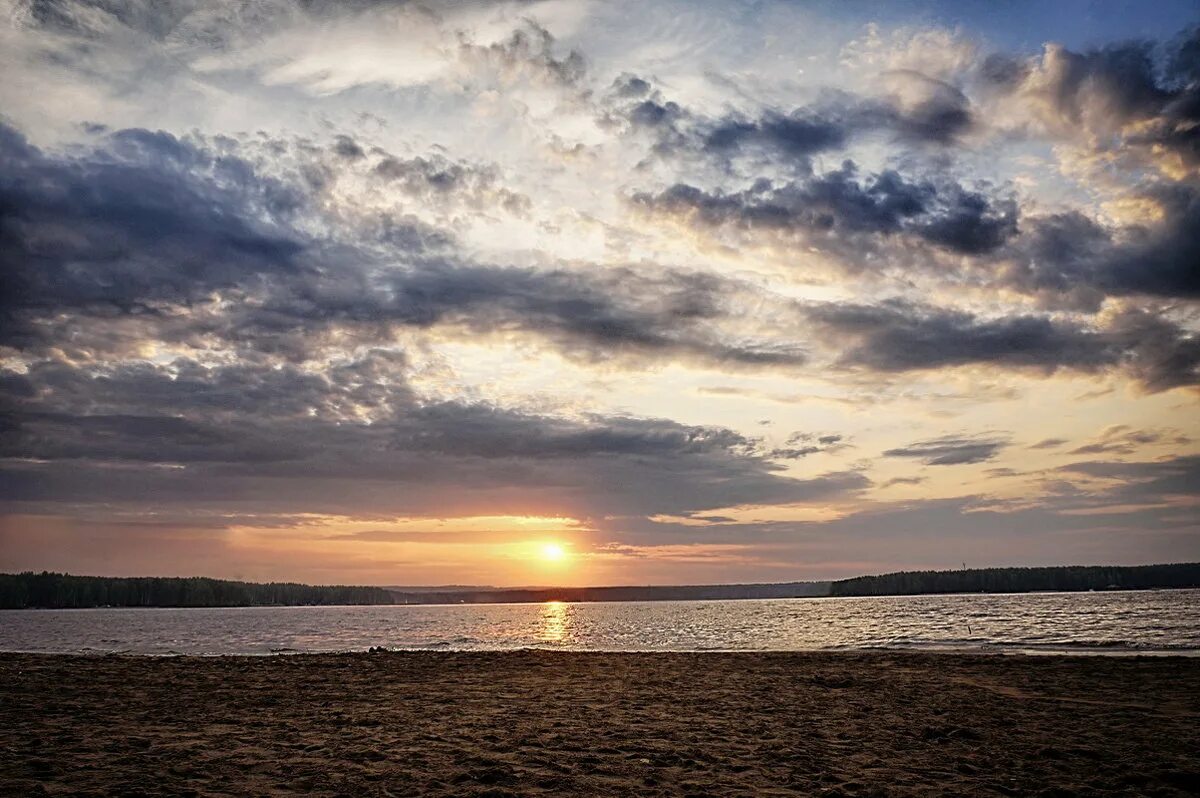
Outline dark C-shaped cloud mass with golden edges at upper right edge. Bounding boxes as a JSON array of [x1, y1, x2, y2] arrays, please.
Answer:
[[964, 28, 1200, 304]]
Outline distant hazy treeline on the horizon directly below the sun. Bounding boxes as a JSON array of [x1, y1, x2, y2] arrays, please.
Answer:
[[392, 582, 829, 604]]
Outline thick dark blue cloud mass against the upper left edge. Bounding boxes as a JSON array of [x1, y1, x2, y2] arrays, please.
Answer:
[[0, 124, 307, 343]]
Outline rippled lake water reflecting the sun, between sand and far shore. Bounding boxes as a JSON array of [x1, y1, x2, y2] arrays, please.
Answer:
[[0, 590, 1200, 654]]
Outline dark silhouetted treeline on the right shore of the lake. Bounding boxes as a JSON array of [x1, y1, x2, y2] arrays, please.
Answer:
[[830, 563, 1200, 595]]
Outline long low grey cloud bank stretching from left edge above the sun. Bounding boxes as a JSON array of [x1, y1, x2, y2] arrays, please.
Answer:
[[0, 352, 869, 516]]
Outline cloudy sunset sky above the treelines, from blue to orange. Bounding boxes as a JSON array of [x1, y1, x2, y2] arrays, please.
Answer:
[[0, 0, 1200, 586]]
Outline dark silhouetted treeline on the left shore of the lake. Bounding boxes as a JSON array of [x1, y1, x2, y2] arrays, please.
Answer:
[[0, 571, 392, 610]]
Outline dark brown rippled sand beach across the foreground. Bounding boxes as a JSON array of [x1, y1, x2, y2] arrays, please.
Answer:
[[0, 652, 1200, 796]]
